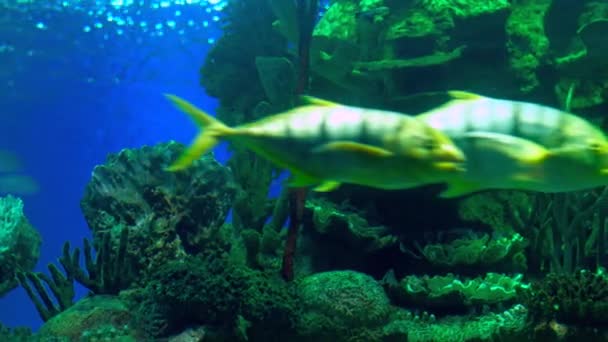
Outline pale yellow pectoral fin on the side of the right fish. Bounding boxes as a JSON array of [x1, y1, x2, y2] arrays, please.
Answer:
[[463, 132, 551, 165]]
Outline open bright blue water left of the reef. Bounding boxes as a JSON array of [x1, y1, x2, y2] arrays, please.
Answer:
[[0, 0, 225, 329]]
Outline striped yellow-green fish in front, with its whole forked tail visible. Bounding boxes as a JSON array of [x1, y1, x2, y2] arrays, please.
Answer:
[[165, 94, 464, 192]]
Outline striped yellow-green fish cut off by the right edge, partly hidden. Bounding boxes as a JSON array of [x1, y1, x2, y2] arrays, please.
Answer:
[[415, 91, 608, 198]]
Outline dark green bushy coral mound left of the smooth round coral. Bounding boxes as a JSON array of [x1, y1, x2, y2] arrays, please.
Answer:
[[138, 250, 296, 340]]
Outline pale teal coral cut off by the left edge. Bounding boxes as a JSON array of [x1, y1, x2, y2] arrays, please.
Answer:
[[0, 195, 42, 297]]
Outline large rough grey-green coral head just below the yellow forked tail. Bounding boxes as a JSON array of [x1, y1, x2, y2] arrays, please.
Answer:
[[81, 142, 237, 269]]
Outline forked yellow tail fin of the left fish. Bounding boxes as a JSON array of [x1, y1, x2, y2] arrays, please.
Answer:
[[165, 94, 232, 171]]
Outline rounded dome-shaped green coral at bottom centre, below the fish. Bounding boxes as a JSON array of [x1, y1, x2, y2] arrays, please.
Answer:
[[297, 271, 392, 341]]
